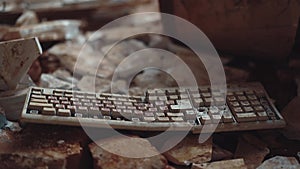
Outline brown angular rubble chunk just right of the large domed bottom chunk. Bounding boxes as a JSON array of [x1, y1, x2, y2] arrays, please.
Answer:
[[164, 135, 212, 165]]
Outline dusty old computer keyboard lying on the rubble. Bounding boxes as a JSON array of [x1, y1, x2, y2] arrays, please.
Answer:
[[21, 83, 285, 133]]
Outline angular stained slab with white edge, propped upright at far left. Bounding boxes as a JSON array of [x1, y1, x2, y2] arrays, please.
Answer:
[[0, 38, 42, 90]]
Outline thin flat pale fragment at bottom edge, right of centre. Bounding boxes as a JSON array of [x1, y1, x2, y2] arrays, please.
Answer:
[[192, 159, 247, 169]]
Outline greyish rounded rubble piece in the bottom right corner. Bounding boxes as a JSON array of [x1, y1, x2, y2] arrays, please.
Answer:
[[257, 156, 300, 169]]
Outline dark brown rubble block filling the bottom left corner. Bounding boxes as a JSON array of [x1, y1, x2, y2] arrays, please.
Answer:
[[0, 125, 86, 169]]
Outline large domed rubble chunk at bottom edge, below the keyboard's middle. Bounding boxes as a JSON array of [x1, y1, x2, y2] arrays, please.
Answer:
[[89, 137, 167, 169]]
